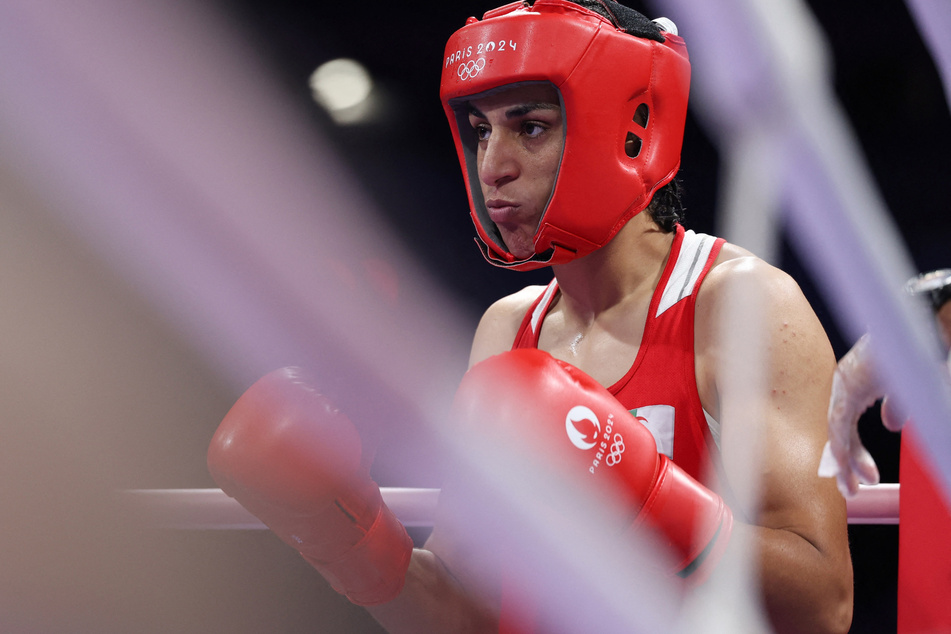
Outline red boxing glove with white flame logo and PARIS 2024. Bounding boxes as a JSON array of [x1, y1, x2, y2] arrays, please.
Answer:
[[455, 349, 733, 583]]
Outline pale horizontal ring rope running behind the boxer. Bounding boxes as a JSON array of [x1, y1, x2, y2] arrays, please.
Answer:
[[121, 484, 899, 530]]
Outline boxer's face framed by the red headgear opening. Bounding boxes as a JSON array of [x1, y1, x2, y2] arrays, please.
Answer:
[[468, 84, 565, 259]]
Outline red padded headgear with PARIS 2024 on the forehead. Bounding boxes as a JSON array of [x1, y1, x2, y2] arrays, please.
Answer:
[[440, 0, 690, 270]]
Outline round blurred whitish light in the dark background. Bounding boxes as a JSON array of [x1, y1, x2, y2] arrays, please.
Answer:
[[310, 58, 373, 124]]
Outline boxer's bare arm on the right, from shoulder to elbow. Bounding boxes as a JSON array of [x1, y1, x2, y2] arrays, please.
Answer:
[[696, 257, 852, 632]]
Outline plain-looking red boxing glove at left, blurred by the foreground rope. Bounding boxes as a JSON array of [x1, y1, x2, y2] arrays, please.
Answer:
[[208, 368, 413, 605]]
